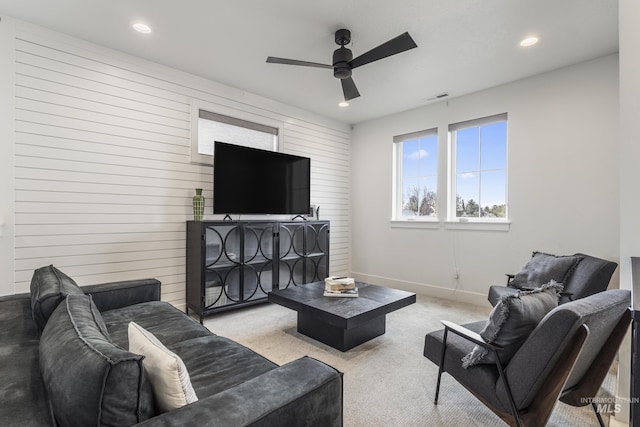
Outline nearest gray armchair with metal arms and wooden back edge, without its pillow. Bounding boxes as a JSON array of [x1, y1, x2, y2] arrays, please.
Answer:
[[424, 289, 631, 426]]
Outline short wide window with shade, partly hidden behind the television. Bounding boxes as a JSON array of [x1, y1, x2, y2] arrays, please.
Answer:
[[191, 109, 278, 165]]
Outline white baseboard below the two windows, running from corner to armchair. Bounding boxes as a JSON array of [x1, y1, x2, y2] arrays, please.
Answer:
[[351, 272, 491, 307]]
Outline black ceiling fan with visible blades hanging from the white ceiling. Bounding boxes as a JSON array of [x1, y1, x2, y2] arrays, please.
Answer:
[[267, 29, 418, 101]]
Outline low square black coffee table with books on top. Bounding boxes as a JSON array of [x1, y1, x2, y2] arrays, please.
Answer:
[[269, 282, 416, 351]]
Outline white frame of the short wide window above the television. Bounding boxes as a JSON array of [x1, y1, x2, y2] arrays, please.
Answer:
[[189, 100, 284, 167]]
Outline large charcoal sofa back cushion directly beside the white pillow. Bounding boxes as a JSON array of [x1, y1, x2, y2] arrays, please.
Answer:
[[40, 295, 153, 426]]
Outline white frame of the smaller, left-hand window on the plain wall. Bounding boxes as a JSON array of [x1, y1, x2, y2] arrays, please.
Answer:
[[391, 126, 441, 223]]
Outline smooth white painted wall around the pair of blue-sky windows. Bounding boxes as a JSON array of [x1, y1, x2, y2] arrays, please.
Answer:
[[351, 55, 619, 304]]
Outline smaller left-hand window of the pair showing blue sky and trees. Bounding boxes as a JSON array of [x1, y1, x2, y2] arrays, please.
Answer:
[[393, 129, 438, 220]]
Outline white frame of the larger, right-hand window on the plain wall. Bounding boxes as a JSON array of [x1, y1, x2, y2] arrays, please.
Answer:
[[447, 113, 510, 228]]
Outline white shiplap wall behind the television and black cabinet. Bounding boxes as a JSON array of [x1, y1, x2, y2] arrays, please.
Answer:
[[10, 24, 350, 307]]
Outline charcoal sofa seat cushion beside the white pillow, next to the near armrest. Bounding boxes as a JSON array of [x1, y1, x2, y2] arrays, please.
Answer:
[[167, 335, 278, 400]]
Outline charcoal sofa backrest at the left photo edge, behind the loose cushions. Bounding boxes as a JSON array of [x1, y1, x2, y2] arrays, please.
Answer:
[[0, 294, 53, 427]]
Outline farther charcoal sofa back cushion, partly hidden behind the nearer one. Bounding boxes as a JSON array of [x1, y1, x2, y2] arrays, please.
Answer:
[[31, 265, 84, 330]]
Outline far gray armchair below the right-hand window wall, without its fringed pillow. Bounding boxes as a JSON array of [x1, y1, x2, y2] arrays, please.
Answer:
[[487, 253, 618, 306]]
